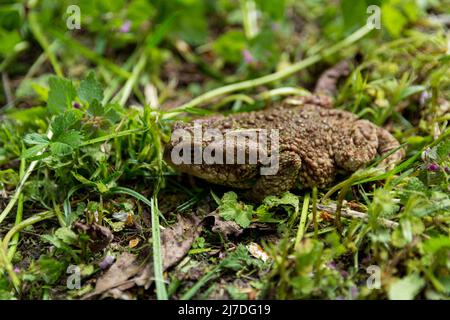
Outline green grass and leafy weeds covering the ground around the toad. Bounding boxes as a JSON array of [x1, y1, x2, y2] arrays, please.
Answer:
[[0, 0, 450, 300]]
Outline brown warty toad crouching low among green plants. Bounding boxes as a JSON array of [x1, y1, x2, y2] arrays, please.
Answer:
[[165, 95, 404, 201]]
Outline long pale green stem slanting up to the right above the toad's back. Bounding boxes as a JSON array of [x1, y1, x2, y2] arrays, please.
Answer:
[[163, 25, 372, 118]]
